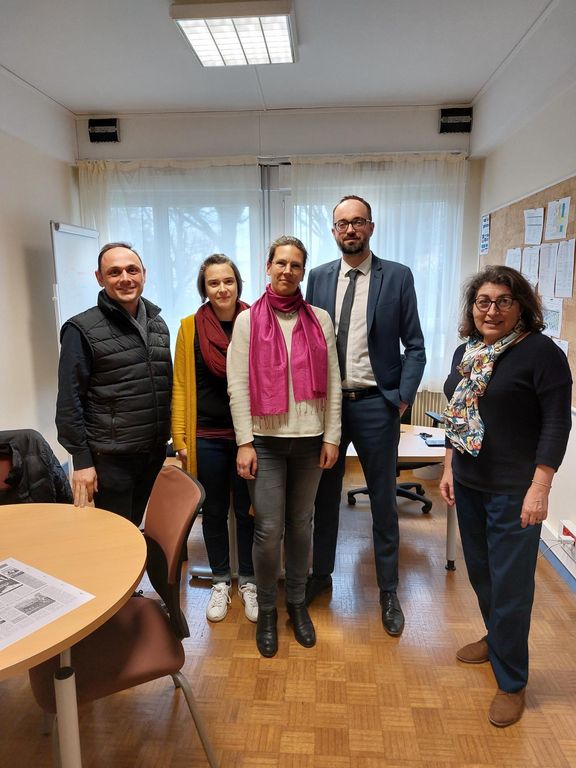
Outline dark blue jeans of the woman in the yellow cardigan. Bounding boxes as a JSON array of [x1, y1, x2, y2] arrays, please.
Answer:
[[196, 437, 254, 583]]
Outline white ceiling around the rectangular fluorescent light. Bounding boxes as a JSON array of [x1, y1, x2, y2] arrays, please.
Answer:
[[0, 0, 557, 115]]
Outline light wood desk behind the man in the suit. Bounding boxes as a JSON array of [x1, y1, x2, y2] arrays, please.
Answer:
[[346, 424, 456, 571]]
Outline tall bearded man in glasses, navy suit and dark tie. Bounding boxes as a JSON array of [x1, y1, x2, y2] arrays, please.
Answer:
[[306, 195, 426, 637]]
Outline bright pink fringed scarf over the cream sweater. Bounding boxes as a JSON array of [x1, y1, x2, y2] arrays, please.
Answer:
[[249, 285, 328, 416]]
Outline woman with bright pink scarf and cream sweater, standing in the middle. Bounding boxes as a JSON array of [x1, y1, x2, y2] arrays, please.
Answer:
[[227, 235, 341, 656]]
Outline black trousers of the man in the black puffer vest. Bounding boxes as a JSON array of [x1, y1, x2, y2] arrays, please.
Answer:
[[93, 445, 166, 526]]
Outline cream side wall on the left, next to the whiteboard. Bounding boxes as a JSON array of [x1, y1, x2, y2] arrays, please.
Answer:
[[0, 129, 79, 459]]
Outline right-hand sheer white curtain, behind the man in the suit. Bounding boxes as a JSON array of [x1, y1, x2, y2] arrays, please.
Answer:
[[291, 154, 467, 392]]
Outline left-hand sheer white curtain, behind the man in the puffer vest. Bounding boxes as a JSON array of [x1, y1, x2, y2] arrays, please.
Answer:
[[79, 157, 263, 343]]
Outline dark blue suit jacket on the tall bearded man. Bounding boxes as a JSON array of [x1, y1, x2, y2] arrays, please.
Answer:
[[306, 254, 426, 406]]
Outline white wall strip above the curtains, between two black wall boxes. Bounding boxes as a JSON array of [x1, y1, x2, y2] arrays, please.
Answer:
[[77, 107, 469, 160]]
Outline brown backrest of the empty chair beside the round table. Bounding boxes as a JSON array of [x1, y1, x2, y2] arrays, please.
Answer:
[[144, 465, 206, 638]]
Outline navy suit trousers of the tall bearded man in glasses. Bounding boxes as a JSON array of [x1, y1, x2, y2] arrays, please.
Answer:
[[312, 396, 400, 592]]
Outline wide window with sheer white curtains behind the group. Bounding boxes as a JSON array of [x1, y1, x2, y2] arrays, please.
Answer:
[[80, 154, 466, 391]]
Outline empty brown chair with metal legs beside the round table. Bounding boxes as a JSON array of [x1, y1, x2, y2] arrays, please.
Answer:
[[30, 466, 218, 768]]
